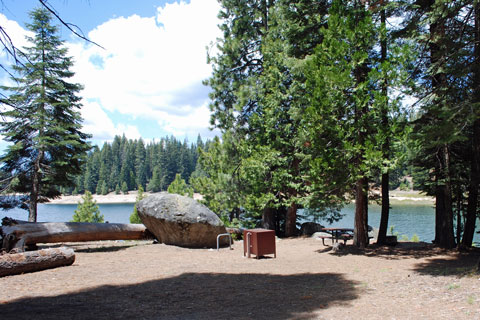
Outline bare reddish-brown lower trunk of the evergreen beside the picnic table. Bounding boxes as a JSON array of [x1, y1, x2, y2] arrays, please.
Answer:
[[353, 178, 368, 249]]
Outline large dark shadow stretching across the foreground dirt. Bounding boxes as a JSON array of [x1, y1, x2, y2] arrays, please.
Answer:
[[0, 273, 362, 319]]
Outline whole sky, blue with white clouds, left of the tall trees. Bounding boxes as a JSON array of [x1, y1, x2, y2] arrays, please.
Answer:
[[0, 0, 221, 144]]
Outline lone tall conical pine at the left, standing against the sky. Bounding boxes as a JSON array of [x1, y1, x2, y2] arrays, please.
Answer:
[[0, 9, 89, 221]]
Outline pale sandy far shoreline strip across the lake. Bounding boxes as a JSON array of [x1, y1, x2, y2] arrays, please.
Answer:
[[45, 191, 435, 205]]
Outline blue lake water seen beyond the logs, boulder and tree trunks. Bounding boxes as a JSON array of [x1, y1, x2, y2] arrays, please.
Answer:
[[0, 203, 480, 243]]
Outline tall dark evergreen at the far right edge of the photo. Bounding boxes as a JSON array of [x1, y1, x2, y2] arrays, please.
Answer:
[[405, 0, 479, 248]]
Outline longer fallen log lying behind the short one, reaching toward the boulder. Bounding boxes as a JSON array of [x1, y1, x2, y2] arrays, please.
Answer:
[[0, 222, 152, 252]]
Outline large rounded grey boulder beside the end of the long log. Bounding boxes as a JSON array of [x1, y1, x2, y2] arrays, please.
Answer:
[[137, 192, 228, 248]]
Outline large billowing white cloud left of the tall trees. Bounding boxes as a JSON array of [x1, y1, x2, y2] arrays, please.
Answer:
[[69, 0, 220, 140]]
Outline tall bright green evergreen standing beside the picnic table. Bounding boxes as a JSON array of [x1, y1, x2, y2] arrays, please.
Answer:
[[302, 1, 408, 247]]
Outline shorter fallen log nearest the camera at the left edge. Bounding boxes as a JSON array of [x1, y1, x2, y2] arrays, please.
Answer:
[[0, 247, 75, 277]]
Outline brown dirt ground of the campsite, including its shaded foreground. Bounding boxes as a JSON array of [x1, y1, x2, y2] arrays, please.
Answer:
[[0, 238, 480, 319]]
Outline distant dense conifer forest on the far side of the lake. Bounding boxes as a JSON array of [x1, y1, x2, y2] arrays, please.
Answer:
[[61, 136, 205, 194]]
